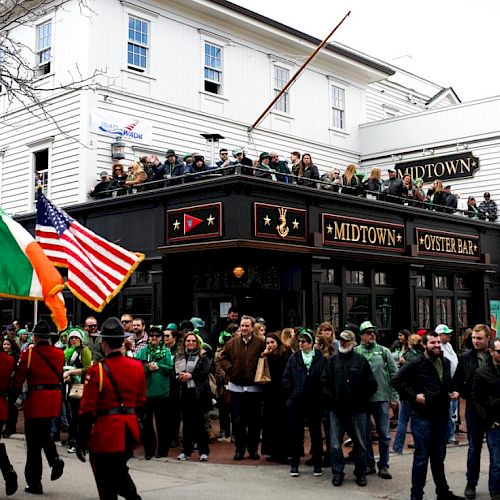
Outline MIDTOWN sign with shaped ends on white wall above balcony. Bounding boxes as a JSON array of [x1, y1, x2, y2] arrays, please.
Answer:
[[394, 153, 479, 183]]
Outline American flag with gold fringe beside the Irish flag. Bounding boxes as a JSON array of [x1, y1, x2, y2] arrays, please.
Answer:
[[35, 190, 144, 312]]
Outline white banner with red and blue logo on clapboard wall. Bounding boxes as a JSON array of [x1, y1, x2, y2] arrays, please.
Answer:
[[90, 110, 153, 145]]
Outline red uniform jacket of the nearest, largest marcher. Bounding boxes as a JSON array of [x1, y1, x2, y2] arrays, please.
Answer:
[[80, 353, 146, 453]]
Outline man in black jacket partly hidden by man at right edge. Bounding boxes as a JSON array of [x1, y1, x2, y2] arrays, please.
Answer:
[[454, 325, 490, 499]]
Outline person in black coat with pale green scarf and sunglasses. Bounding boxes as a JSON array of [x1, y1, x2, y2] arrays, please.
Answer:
[[283, 328, 325, 477]]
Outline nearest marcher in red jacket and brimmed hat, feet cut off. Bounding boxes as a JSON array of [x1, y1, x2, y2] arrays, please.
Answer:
[[76, 318, 146, 500]]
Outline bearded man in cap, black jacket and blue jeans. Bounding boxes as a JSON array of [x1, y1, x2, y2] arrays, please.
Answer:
[[321, 330, 377, 486]]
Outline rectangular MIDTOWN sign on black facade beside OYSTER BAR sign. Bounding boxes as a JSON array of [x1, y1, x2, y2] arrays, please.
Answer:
[[323, 214, 405, 252]]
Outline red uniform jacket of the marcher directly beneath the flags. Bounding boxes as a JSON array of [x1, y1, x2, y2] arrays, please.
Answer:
[[14, 343, 64, 418]]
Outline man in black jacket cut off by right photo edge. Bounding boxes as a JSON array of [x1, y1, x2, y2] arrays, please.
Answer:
[[472, 337, 500, 500]]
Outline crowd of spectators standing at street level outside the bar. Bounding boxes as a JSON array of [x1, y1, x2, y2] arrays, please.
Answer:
[[2, 314, 500, 500]]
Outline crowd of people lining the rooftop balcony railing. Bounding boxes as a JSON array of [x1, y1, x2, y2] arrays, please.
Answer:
[[90, 147, 497, 222]]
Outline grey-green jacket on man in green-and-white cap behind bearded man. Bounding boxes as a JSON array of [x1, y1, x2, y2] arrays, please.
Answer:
[[356, 343, 399, 403]]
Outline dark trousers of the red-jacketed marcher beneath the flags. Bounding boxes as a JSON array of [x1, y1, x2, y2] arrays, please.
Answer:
[[24, 418, 59, 486]]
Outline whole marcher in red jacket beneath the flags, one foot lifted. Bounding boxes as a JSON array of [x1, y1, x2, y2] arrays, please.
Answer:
[[14, 321, 64, 495]]
